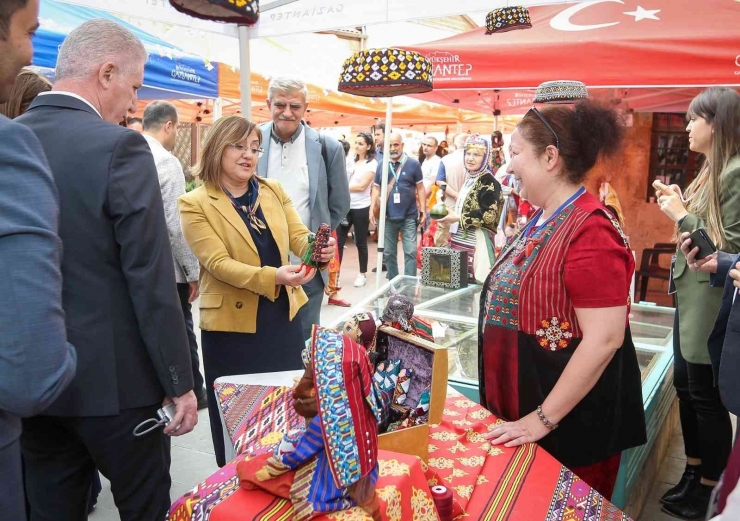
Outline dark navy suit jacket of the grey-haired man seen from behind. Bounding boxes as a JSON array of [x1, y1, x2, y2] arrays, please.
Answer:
[[17, 94, 193, 416]]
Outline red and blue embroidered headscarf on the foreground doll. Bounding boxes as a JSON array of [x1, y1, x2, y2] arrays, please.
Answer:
[[311, 326, 381, 488]]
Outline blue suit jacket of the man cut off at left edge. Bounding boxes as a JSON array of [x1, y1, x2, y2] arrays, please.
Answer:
[[0, 116, 77, 448]]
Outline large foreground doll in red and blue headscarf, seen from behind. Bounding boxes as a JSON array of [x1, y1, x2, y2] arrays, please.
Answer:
[[237, 326, 381, 521]]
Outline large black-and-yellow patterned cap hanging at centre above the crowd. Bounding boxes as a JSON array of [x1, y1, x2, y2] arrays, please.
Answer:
[[338, 47, 433, 98]]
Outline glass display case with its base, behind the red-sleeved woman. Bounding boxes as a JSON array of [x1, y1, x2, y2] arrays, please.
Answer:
[[332, 275, 675, 507]]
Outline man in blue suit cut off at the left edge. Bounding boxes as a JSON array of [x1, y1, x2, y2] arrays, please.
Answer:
[[0, 0, 77, 520]]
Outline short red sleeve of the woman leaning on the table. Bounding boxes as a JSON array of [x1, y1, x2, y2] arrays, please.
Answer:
[[565, 213, 634, 308]]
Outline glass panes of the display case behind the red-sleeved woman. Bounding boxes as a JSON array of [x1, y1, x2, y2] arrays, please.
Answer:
[[334, 275, 674, 392]]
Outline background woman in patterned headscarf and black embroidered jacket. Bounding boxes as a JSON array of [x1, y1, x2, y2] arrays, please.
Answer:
[[430, 134, 504, 283]]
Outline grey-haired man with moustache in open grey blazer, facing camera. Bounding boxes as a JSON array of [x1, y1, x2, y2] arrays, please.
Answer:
[[257, 78, 349, 338]]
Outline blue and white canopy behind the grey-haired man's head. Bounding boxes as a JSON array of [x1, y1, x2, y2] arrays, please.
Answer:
[[33, 0, 218, 99]]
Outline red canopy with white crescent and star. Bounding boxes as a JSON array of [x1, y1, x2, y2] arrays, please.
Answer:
[[409, 0, 740, 114]]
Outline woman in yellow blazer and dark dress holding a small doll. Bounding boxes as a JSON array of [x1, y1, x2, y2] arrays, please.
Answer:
[[178, 116, 335, 466]]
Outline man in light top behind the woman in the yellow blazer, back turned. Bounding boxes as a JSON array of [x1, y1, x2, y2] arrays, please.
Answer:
[[142, 100, 208, 409]]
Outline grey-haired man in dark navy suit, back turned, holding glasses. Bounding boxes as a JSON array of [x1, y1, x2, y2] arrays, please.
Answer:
[[18, 20, 197, 521]]
